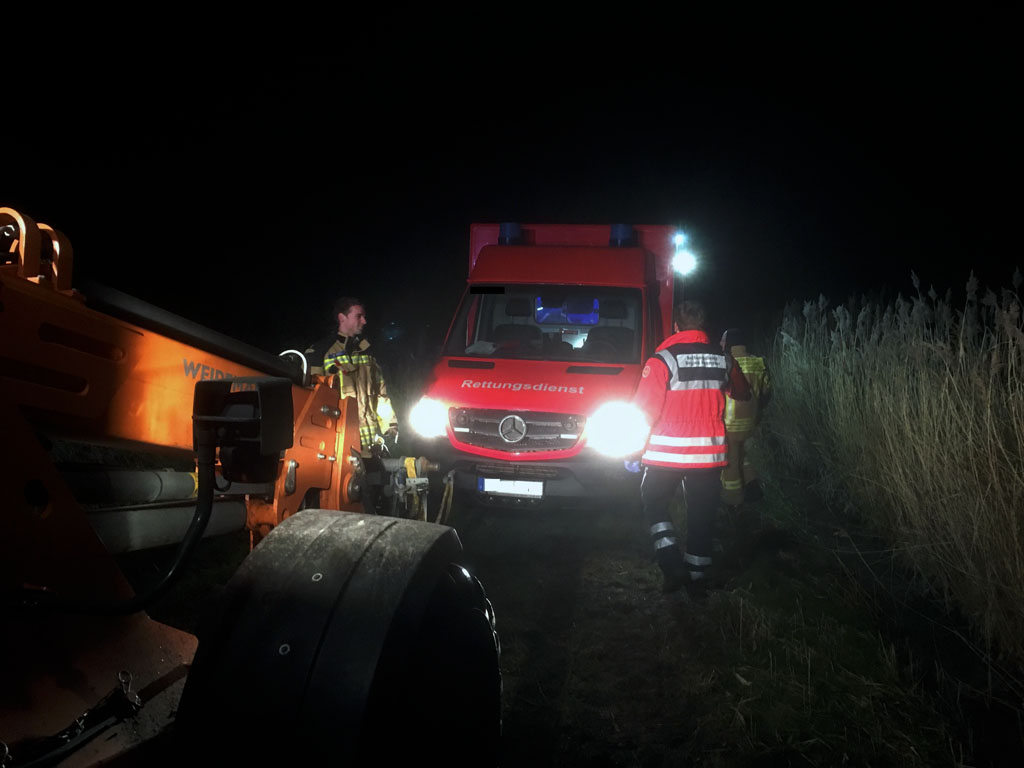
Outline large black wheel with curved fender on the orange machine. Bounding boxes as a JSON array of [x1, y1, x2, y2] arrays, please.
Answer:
[[177, 510, 501, 766]]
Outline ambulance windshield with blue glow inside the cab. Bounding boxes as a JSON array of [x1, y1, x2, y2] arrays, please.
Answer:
[[444, 285, 643, 364]]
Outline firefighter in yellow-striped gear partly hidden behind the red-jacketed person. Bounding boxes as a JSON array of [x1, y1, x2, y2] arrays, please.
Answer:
[[722, 328, 771, 507]]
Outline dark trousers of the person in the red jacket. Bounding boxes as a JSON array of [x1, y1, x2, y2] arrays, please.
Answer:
[[640, 467, 722, 571]]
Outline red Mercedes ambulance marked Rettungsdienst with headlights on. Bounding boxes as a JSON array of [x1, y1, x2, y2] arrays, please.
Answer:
[[410, 223, 677, 507]]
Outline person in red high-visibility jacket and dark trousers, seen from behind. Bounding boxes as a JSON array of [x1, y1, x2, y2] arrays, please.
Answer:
[[633, 302, 751, 596]]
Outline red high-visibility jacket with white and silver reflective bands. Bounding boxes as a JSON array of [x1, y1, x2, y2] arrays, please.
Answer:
[[633, 331, 751, 469]]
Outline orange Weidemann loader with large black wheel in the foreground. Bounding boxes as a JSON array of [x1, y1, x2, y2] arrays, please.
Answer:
[[0, 208, 501, 768]]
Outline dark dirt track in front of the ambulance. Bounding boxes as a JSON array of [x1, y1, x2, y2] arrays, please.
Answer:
[[456, 509, 708, 768]]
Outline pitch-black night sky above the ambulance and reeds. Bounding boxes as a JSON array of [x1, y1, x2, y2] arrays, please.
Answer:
[[0, 10, 1024, 360]]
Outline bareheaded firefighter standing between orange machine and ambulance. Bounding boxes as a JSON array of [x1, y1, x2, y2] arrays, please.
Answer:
[[305, 296, 398, 453]]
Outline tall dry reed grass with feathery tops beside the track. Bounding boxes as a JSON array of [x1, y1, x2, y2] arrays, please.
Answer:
[[767, 272, 1024, 664]]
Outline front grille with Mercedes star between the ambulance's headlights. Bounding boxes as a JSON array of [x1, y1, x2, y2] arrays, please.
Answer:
[[449, 408, 587, 453]]
